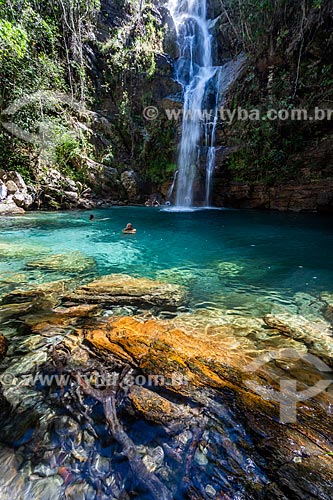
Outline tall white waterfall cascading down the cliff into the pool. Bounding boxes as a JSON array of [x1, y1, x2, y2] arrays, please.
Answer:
[[168, 0, 221, 208]]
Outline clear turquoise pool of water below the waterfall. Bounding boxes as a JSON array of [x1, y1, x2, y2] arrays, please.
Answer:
[[0, 207, 333, 316]]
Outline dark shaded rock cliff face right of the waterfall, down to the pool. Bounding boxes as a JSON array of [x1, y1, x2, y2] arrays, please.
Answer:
[[206, 0, 333, 211]]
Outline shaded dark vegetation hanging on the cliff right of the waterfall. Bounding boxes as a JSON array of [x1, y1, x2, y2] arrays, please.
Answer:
[[220, 0, 333, 184]]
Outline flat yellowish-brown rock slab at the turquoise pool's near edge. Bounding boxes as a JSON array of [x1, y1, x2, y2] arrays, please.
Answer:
[[66, 274, 186, 308]]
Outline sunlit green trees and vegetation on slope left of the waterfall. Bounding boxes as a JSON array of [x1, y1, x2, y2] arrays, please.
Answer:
[[0, 0, 174, 189]]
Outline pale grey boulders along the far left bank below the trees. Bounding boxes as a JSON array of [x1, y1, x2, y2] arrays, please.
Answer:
[[0, 168, 145, 215]]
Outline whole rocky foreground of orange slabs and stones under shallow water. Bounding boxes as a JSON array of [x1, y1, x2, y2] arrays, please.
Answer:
[[0, 275, 333, 500]]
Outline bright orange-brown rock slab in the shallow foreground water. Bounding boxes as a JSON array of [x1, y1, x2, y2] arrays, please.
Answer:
[[84, 317, 252, 392]]
